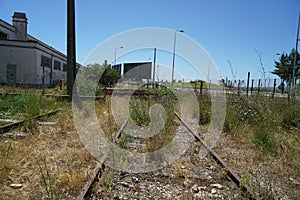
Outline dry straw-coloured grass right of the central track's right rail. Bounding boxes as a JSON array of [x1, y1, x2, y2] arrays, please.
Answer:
[[216, 129, 300, 199]]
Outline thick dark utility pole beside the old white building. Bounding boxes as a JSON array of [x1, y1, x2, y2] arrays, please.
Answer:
[[67, 0, 76, 99]]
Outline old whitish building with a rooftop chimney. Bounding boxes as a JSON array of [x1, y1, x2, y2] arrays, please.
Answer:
[[0, 12, 67, 86]]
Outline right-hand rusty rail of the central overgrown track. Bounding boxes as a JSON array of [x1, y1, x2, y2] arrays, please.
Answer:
[[174, 112, 260, 200]]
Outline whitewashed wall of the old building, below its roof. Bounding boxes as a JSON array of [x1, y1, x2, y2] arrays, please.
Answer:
[[0, 40, 66, 85]]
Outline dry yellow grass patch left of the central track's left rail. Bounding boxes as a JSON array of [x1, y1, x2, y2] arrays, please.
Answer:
[[0, 103, 96, 199]]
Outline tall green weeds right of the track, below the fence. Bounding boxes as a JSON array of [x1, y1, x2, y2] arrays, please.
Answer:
[[219, 95, 300, 154]]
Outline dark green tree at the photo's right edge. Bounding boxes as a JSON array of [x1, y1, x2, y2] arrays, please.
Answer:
[[271, 49, 300, 82]]
